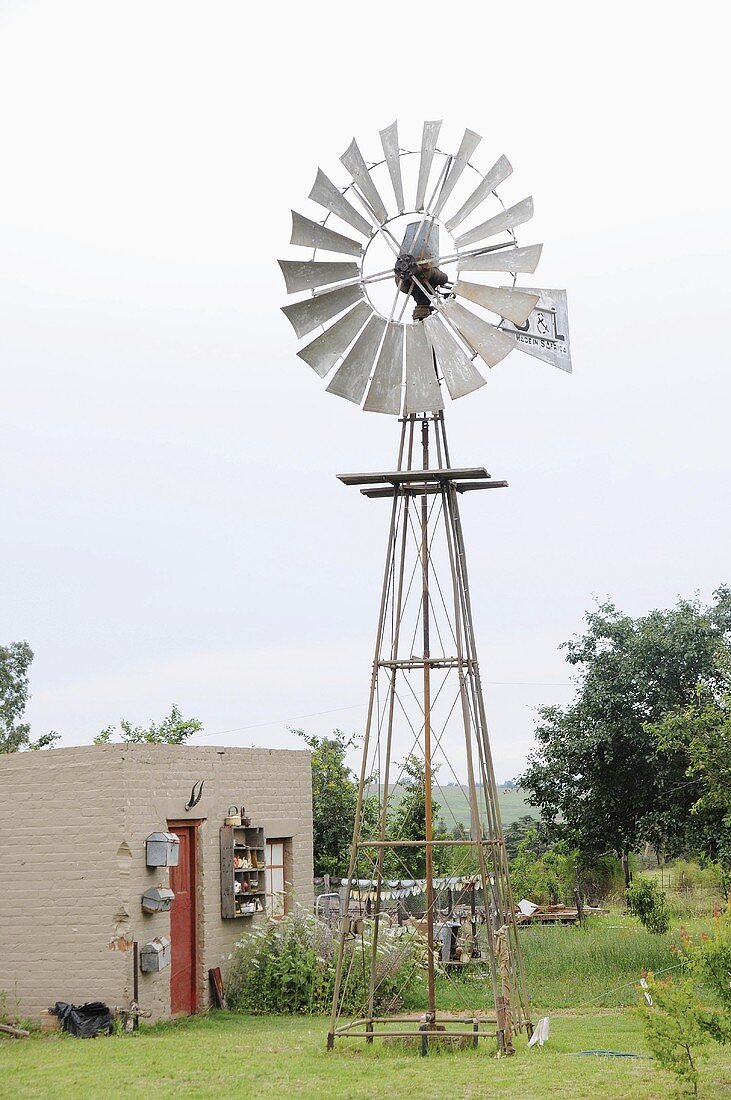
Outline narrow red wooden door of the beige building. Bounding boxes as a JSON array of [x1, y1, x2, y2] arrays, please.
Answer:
[[168, 825, 198, 1015]]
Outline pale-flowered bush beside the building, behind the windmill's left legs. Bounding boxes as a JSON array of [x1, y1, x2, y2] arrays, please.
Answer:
[[226, 913, 428, 1015]]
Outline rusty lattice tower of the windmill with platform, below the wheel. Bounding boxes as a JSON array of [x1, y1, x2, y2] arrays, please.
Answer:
[[328, 411, 532, 1054]]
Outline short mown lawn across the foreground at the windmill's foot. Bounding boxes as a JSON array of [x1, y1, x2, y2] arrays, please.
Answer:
[[0, 1009, 731, 1100]]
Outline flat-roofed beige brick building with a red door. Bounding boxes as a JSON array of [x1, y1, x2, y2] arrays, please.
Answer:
[[0, 745, 312, 1020]]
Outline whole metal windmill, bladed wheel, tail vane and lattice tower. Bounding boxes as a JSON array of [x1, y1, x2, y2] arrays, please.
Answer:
[[279, 121, 571, 1053]]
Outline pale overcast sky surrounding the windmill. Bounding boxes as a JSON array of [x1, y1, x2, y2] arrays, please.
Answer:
[[0, 0, 731, 778]]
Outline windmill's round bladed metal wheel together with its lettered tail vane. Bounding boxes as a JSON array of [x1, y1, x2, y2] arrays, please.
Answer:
[[279, 122, 571, 415]]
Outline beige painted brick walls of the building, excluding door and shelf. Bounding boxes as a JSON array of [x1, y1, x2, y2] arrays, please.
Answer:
[[0, 745, 312, 1019]]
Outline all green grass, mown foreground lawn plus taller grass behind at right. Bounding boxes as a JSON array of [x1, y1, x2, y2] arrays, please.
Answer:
[[0, 914, 731, 1100]]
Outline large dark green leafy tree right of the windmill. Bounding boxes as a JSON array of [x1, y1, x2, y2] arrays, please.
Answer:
[[520, 587, 731, 879]]
